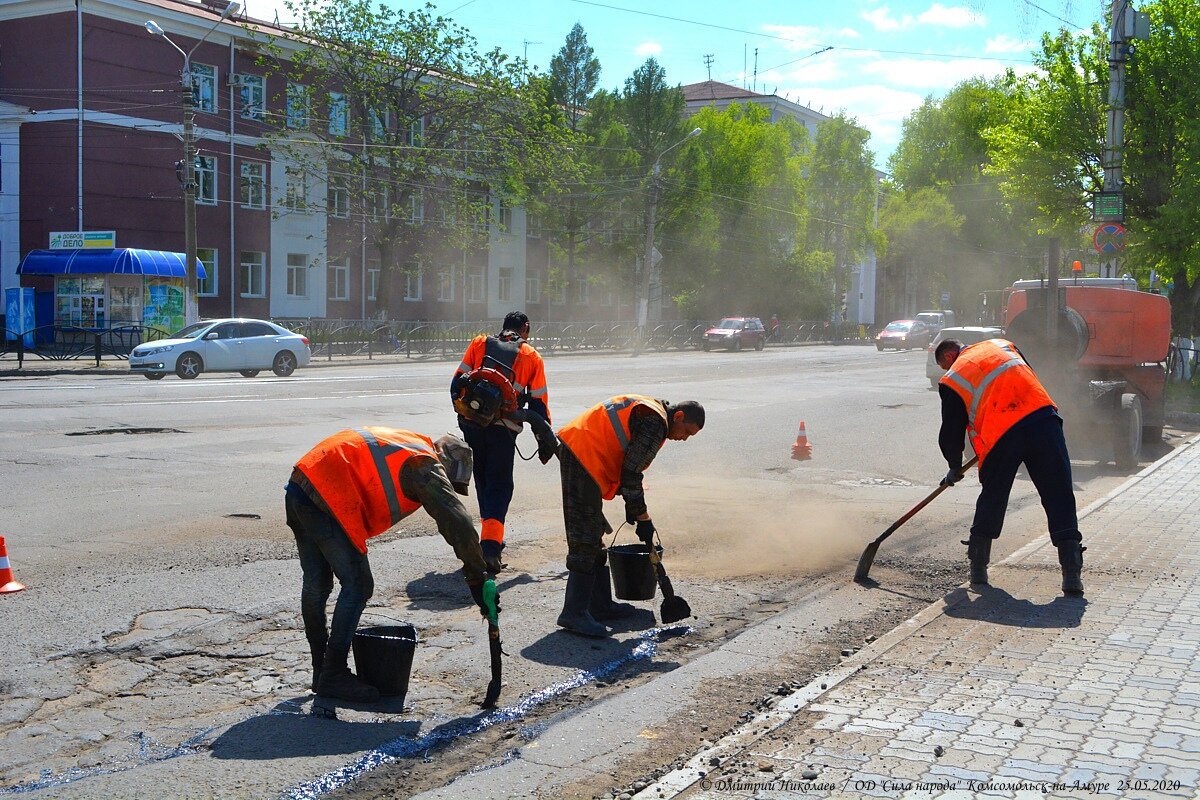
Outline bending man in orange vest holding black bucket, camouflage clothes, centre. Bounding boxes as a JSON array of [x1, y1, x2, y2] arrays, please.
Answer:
[[558, 395, 704, 637]]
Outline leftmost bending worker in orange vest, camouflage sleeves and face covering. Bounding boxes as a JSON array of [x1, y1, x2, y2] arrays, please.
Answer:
[[284, 426, 487, 703]]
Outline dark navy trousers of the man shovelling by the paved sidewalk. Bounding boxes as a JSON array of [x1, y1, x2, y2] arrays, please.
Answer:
[[971, 414, 1082, 546]]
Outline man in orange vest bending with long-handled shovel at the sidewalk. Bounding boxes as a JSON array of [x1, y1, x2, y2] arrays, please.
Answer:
[[934, 338, 1084, 595]]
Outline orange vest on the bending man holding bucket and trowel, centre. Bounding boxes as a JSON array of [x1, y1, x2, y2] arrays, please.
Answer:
[[558, 395, 667, 500]]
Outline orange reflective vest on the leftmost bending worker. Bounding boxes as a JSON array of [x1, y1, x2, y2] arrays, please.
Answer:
[[296, 427, 437, 553]]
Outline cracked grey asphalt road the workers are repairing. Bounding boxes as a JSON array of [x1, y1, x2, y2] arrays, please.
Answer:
[[0, 347, 1152, 798]]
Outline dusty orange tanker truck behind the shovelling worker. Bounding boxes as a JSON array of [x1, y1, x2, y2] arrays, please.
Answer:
[[1003, 278, 1171, 470]]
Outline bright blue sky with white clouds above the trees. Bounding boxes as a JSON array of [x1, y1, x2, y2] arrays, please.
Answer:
[[246, 0, 1108, 167]]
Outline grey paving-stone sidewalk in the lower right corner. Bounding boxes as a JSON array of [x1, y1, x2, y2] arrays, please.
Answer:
[[636, 439, 1200, 799]]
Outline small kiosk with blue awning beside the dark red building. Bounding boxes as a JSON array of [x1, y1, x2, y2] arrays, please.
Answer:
[[17, 247, 208, 332]]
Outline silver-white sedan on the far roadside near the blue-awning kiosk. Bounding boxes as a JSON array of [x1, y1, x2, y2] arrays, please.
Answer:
[[130, 319, 312, 380]]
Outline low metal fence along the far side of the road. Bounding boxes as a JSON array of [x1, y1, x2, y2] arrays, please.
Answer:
[[0, 317, 875, 366]]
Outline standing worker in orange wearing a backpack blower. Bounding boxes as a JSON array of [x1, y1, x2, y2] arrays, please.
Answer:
[[450, 311, 550, 572]]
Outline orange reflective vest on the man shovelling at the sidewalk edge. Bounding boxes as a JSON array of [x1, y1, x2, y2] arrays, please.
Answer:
[[940, 339, 1054, 467]]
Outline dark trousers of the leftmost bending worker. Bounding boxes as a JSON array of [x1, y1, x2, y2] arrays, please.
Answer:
[[283, 482, 374, 652]]
